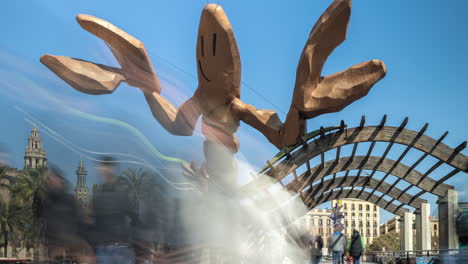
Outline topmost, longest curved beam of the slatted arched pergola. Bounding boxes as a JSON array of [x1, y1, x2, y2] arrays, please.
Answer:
[[266, 126, 468, 184]]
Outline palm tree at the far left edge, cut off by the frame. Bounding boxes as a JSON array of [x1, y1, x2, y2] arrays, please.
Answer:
[[0, 200, 30, 257]]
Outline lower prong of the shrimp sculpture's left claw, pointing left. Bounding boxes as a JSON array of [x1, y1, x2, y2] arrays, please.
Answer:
[[41, 54, 125, 95]]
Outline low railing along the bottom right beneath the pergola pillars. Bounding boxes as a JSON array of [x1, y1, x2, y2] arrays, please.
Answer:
[[367, 249, 468, 264]]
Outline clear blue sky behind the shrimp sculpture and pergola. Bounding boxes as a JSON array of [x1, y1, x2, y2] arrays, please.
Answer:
[[0, 0, 468, 224]]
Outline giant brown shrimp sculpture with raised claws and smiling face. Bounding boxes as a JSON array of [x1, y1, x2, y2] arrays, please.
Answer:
[[41, 0, 386, 189]]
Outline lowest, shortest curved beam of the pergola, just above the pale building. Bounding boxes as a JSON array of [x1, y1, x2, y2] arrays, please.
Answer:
[[306, 189, 409, 216]]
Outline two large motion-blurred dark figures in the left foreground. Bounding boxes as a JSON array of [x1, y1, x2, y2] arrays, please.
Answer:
[[33, 157, 148, 264]]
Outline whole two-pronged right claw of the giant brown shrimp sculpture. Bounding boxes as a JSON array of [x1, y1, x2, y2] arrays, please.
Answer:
[[292, 0, 386, 118]]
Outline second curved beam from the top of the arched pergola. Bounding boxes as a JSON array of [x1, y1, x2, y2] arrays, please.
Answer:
[[285, 156, 453, 196]]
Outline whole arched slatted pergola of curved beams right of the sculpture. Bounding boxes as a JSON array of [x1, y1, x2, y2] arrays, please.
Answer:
[[243, 115, 468, 215]]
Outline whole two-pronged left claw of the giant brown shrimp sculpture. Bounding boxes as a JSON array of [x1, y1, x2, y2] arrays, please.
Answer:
[[41, 15, 161, 94]]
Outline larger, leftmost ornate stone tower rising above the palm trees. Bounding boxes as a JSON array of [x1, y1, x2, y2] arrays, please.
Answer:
[[24, 128, 47, 169]]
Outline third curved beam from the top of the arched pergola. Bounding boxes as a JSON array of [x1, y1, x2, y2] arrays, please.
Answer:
[[300, 176, 427, 208]]
